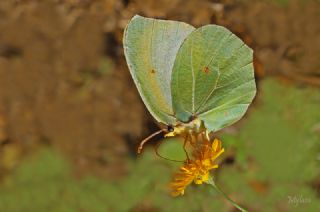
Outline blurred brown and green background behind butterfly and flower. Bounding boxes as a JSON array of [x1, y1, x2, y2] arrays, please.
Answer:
[[0, 0, 320, 212]]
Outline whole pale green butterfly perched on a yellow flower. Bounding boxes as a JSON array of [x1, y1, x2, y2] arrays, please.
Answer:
[[123, 15, 256, 152]]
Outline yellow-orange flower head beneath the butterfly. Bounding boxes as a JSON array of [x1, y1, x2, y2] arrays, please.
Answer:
[[170, 136, 224, 196]]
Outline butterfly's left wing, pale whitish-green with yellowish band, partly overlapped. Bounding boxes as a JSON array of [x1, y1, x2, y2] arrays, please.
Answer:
[[123, 15, 194, 125]]
